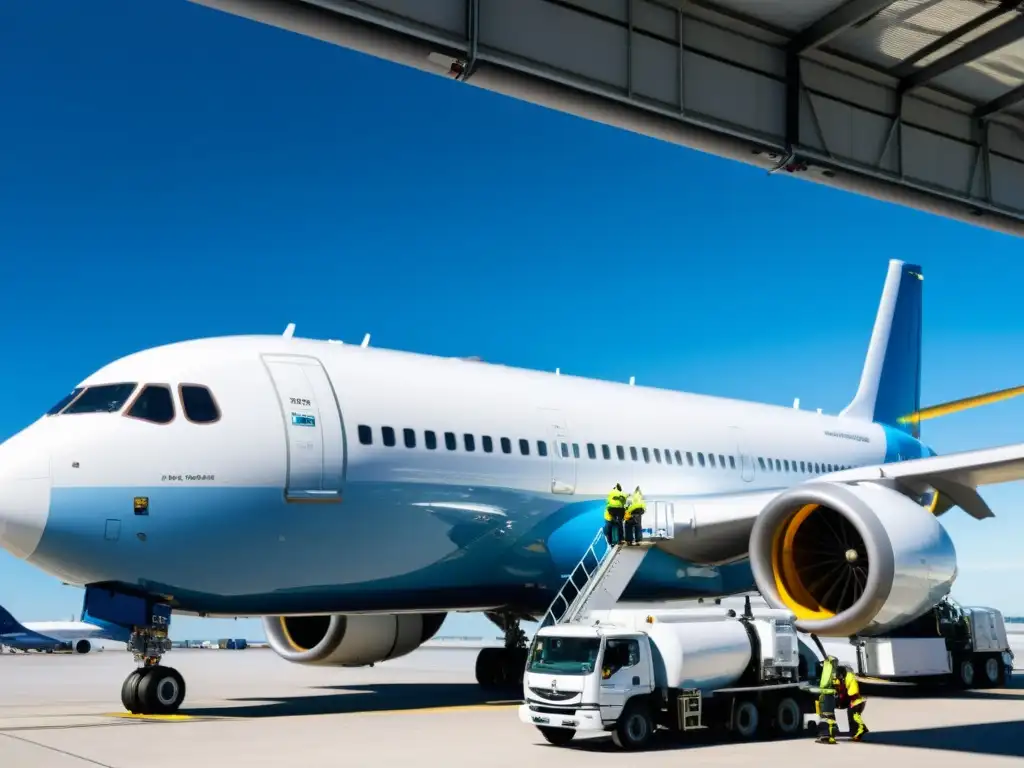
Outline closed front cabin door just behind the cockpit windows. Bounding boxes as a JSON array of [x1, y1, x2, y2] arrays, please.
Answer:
[[263, 355, 345, 502]]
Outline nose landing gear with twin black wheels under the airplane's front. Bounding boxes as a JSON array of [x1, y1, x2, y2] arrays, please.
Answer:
[[121, 611, 185, 715]]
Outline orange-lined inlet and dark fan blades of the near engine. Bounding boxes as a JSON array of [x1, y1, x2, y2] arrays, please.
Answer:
[[772, 504, 869, 621]]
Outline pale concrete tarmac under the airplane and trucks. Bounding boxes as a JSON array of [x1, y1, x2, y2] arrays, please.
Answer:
[[0, 649, 1024, 768]]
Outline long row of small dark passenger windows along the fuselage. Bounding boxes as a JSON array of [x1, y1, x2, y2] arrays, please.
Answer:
[[358, 424, 848, 474]]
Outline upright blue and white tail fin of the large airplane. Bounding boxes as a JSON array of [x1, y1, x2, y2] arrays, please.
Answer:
[[842, 259, 924, 438]]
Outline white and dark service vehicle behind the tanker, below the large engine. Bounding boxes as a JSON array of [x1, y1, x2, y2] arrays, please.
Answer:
[[823, 598, 1014, 689]]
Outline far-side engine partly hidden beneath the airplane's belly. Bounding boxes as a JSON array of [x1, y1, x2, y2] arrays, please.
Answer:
[[263, 613, 447, 667]]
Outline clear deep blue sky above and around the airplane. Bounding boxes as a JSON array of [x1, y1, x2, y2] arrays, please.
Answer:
[[0, 0, 1024, 637]]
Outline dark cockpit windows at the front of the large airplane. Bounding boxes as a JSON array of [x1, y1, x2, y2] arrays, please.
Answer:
[[46, 382, 220, 424]]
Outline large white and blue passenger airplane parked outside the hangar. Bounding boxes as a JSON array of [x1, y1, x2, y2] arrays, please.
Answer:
[[0, 260, 1024, 714]]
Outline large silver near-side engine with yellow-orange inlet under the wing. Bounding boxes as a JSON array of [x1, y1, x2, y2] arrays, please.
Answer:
[[750, 482, 956, 637]]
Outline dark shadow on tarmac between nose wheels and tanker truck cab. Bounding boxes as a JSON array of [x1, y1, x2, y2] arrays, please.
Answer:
[[180, 683, 522, 718]]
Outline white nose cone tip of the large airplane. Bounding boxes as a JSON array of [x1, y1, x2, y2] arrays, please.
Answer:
[[0, 440, 50, 560]]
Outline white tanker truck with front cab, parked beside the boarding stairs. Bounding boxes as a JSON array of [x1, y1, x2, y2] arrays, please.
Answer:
[[519, 607, 814, 750]]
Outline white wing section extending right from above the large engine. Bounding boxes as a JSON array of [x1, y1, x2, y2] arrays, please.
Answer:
[[822, 442, 1024, 520]]
